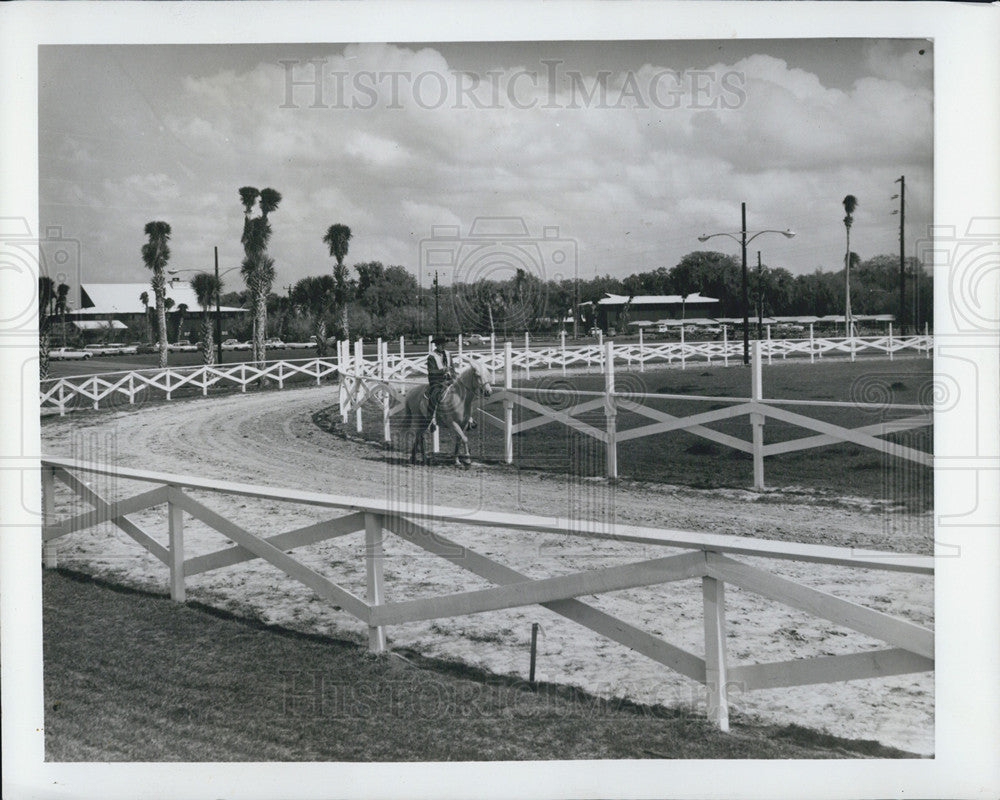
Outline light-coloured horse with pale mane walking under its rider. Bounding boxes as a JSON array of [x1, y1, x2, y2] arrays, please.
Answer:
[[403, 362, 493, 467]]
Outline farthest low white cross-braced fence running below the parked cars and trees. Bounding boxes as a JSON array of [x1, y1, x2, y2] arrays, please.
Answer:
[[39, 332, 933, 416]]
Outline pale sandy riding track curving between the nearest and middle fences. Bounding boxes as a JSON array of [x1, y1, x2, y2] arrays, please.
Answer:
[[42, 387, 934, 754]]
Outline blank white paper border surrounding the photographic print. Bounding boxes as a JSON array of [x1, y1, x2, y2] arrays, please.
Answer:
[[0, 2, 1000, 800]]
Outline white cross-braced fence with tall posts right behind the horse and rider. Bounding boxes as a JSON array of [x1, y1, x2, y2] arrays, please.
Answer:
[[340, 341, 933, 489]]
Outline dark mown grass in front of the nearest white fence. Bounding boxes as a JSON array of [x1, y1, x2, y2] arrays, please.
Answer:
[[43, 570, 911, 761]]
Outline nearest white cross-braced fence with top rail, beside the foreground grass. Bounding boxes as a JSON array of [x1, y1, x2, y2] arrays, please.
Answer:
[[41, 458, 934, 730]]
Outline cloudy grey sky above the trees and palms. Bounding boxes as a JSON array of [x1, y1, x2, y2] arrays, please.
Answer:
[[39, 39, 933, 304]]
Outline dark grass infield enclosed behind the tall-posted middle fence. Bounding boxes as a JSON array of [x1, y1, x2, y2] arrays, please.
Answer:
[[352, 358, 933, 512]]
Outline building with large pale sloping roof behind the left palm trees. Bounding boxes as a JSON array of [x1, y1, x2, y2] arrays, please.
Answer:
[[66, 280, 247, 341]]
